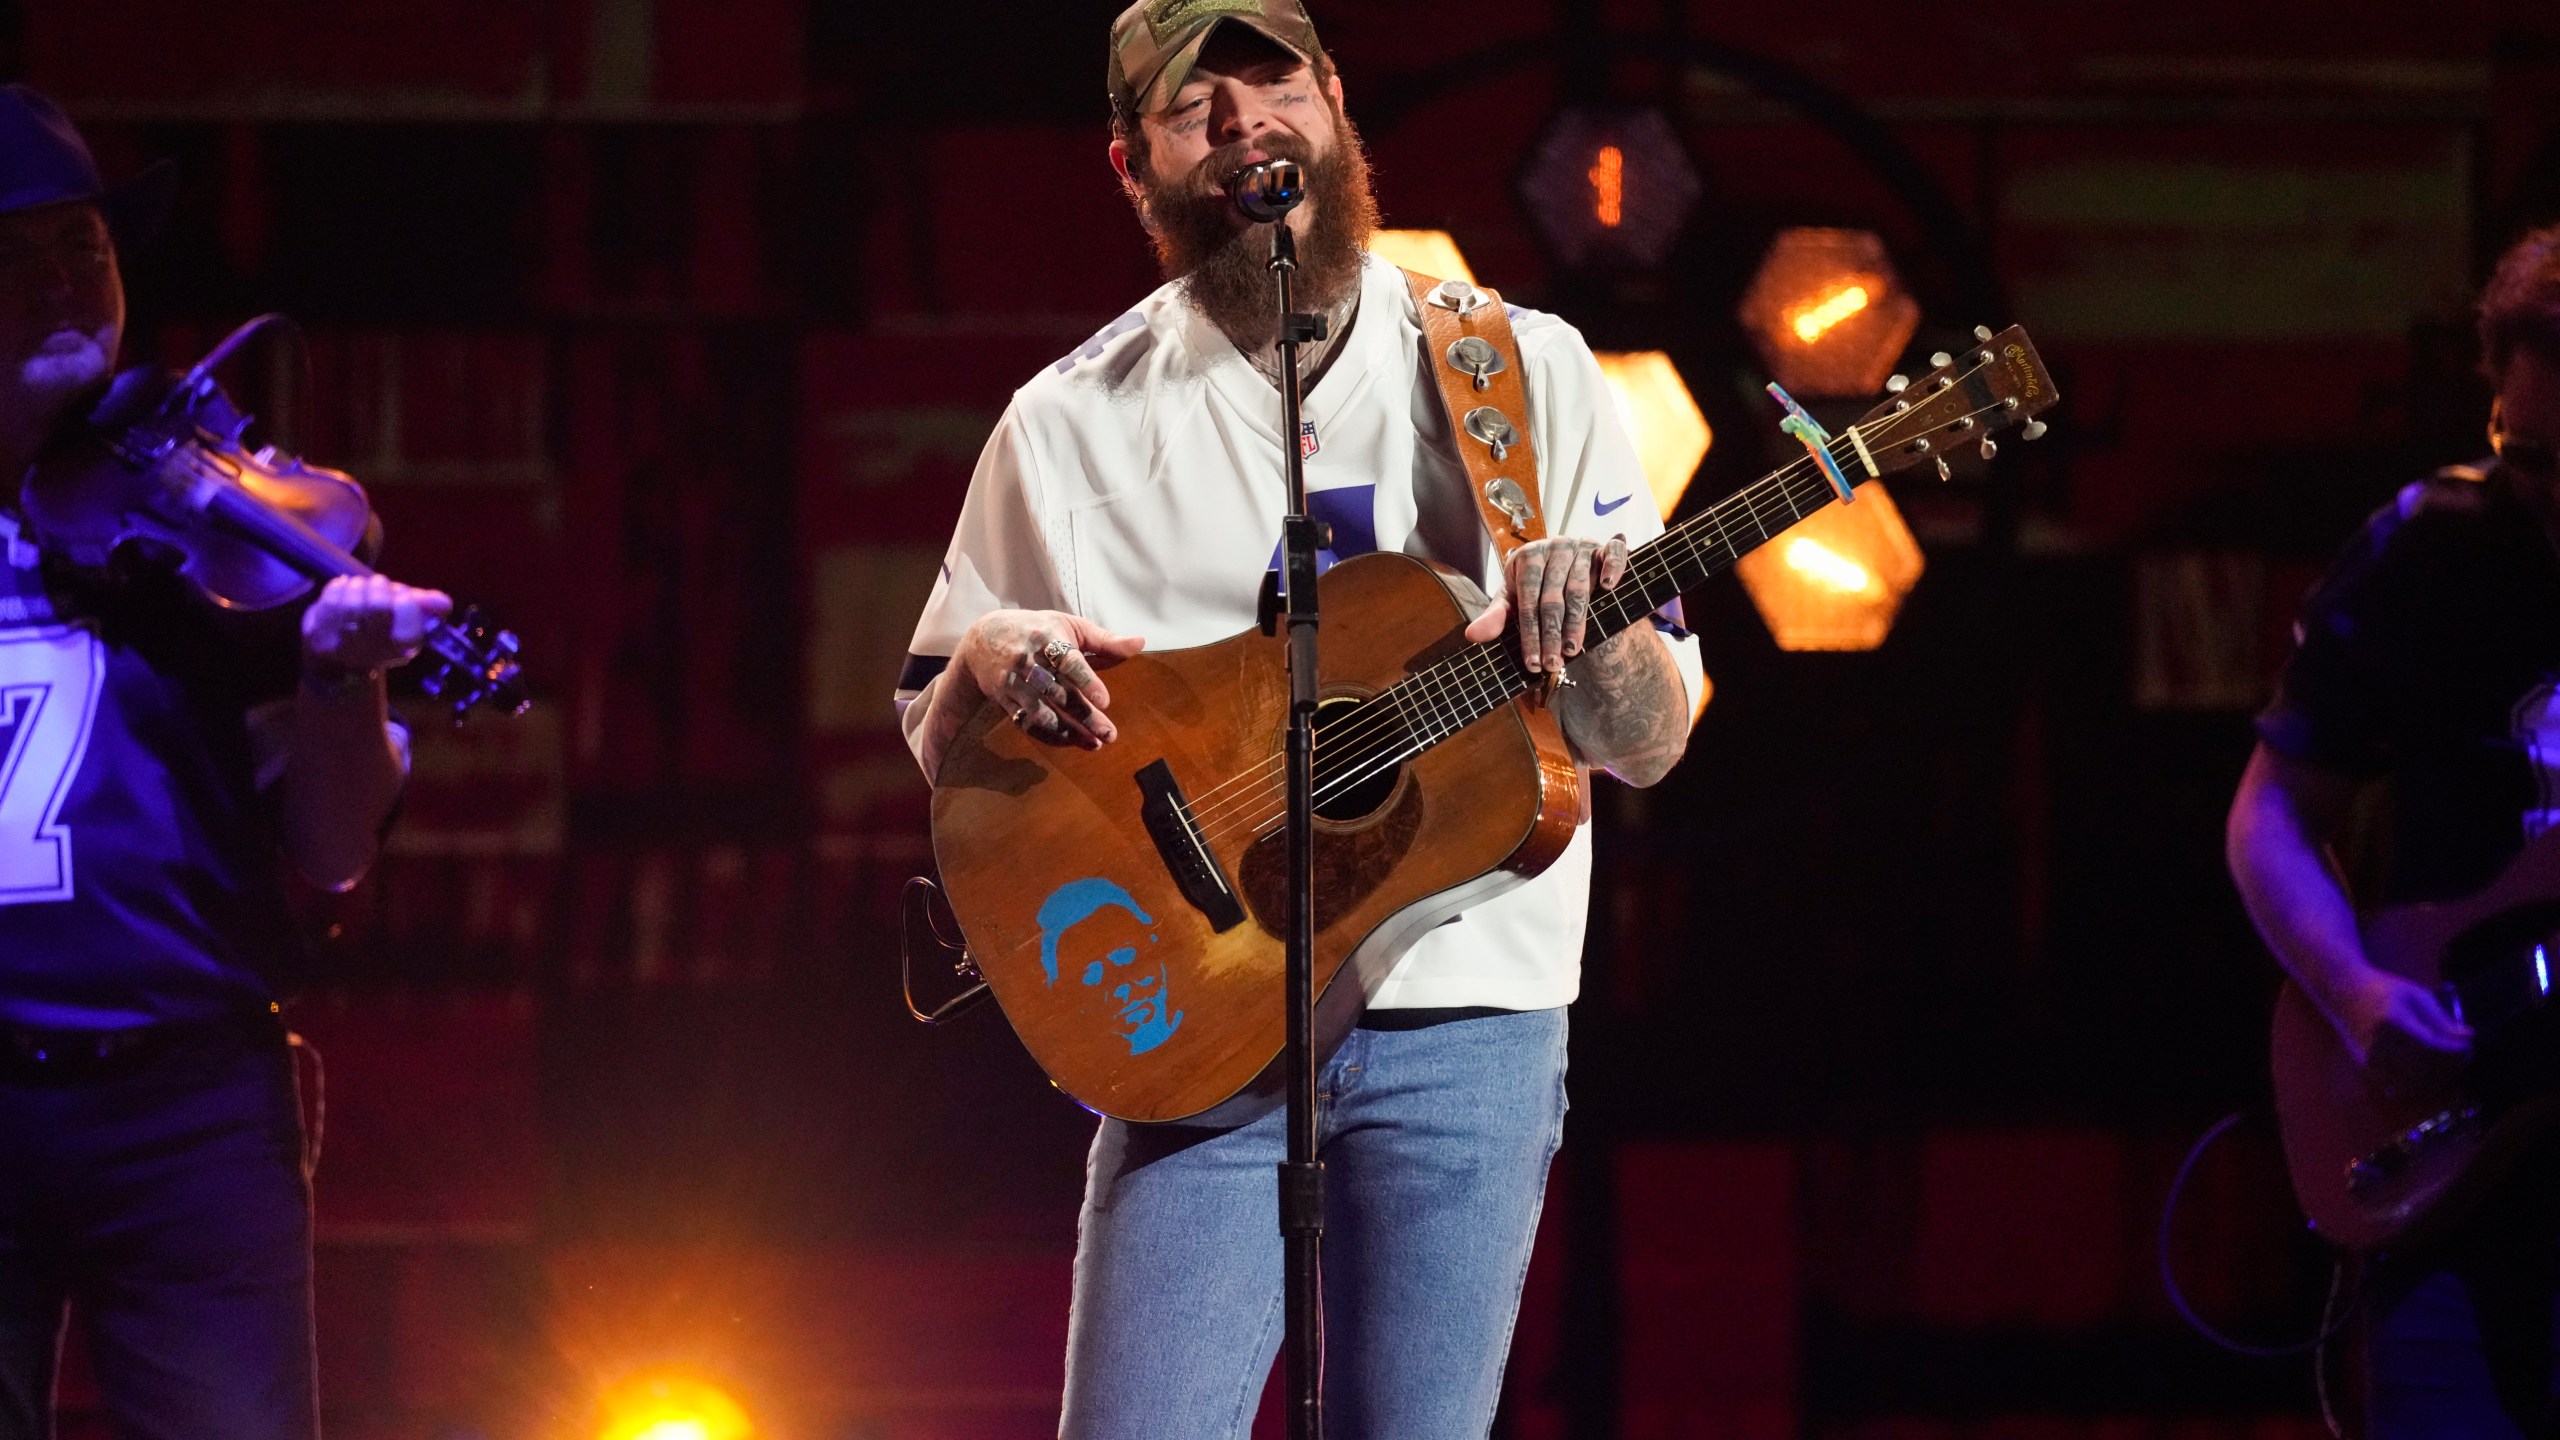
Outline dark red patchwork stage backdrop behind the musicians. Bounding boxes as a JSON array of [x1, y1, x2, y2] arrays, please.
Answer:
[[20, 0, 2560, 1440]]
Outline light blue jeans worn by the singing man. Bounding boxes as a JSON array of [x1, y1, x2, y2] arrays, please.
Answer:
[[1060, 1010, 1564, 1440]]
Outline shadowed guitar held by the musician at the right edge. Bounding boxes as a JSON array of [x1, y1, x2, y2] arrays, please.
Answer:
[[2271, 830, 2560, 1250]]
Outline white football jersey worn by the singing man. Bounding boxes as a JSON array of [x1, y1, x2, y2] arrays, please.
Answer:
[[899, 256, 1705, 1010]]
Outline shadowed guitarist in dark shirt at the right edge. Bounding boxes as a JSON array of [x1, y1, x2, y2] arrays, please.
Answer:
[[2227, 228, 2560, 1440]]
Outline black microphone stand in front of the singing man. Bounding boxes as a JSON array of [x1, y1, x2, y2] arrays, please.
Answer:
[[1257, 170, 1326, 1440]]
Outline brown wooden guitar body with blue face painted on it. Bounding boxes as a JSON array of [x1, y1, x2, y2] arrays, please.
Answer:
[[934, 553, 1582, 1122]]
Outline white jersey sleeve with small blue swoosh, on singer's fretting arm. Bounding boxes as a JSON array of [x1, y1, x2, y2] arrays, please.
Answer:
[[1523, 323, 1708, 715]]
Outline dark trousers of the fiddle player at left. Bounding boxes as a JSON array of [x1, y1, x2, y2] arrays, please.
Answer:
[[0, 1035, 317, 1440]]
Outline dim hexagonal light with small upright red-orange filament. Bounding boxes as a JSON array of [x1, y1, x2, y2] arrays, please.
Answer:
[[1521, 108, 1697, 269]]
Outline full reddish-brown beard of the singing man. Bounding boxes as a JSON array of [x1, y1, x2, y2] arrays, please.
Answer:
[[1139, 110, 1377, 354]]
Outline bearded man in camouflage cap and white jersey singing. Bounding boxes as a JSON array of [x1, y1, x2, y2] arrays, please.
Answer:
[[899, 0, 1702, 1440]]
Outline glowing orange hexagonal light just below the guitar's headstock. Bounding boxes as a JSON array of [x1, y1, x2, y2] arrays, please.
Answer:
[[1733, 482, 1925, 651]]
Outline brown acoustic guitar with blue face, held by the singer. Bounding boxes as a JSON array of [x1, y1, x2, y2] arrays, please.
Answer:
[[932, 328, 2056, 1122]]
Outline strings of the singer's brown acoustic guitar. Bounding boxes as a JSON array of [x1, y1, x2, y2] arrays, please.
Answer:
[[1196, 361, 2007, 843]]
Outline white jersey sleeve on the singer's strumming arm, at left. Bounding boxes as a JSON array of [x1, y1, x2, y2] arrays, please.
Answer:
[[893, 400, 1068, 776]]
